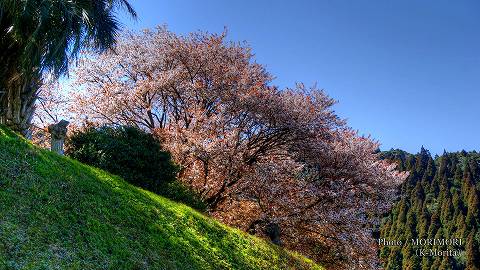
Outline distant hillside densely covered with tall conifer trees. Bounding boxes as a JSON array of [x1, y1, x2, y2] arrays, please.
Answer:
[[380, 148, 480, 269]]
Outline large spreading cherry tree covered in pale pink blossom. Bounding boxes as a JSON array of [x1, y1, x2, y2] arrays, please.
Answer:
[[70, 27, 406, 269]]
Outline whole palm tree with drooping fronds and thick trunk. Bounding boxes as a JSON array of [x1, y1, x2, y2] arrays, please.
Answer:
[[0, 0, 136, 134]]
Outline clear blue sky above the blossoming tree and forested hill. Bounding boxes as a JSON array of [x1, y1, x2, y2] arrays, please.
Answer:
[[116, 0, 480, 154]]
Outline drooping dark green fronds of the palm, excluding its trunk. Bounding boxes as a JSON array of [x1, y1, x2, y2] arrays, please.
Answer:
[[0, 0, 137, 75]]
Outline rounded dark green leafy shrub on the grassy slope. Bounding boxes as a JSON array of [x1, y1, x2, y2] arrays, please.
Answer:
[[66, 126, 178, 193]]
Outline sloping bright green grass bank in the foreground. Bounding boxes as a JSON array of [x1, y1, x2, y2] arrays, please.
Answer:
[[0, 127, 322, 270]]
